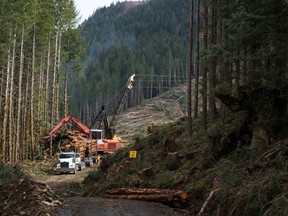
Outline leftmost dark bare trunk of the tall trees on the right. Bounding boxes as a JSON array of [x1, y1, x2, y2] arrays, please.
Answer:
[[187, 0, 194, 137]]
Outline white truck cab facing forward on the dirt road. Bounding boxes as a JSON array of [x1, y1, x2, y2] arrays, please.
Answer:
[[57, 152, 85, 174]]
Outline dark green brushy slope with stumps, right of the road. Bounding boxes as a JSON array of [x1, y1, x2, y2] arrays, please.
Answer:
[[84, 112, 288, 216]]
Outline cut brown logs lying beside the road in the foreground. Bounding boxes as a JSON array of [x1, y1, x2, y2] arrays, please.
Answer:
[[103, 188, 188, 207]]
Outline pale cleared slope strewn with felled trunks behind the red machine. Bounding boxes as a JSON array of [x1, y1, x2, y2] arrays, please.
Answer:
[[116, 86, 187, 141]]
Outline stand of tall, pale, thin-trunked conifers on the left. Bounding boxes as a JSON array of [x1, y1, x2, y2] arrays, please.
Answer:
[[0, 0, 81, 162]]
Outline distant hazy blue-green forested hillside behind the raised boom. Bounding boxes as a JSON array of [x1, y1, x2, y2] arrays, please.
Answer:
[[69, 0, 189, 122]]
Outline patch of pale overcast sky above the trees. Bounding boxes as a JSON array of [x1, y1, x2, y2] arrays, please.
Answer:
[[74, 0, 134, 23]]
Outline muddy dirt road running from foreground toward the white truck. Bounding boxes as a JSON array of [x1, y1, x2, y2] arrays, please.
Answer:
[[39, 166, 188, 216]]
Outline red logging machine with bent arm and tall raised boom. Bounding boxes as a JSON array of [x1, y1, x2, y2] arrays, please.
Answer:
[[40, 74, 135, 154]]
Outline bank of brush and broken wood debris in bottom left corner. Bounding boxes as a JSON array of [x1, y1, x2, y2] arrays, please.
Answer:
[[0, 165, 63, 216]]
